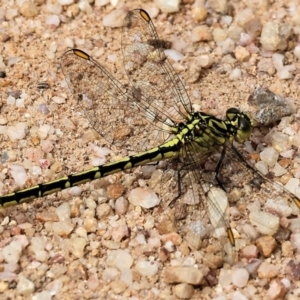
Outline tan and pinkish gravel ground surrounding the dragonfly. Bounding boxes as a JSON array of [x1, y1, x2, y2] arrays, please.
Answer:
[[0, 0, 300, 300]]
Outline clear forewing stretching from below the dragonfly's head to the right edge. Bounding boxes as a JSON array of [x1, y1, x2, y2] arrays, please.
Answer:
[[218, 144, 300, 235]]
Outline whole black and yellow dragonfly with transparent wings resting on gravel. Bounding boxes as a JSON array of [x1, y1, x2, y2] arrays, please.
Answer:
[[0, 9, 300, 264]]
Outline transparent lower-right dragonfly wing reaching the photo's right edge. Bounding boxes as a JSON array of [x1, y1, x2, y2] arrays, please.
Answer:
[[217, 145, 300, 216]]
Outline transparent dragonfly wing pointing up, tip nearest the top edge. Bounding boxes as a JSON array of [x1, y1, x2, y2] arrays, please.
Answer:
[[122, 9, 192, 126]]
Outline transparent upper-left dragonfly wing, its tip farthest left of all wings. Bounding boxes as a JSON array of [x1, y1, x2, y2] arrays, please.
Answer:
[[61, 49, 171, 151]]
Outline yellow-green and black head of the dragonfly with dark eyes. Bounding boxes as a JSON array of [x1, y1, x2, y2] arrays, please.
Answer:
[[226, 107, 253, 143]]
